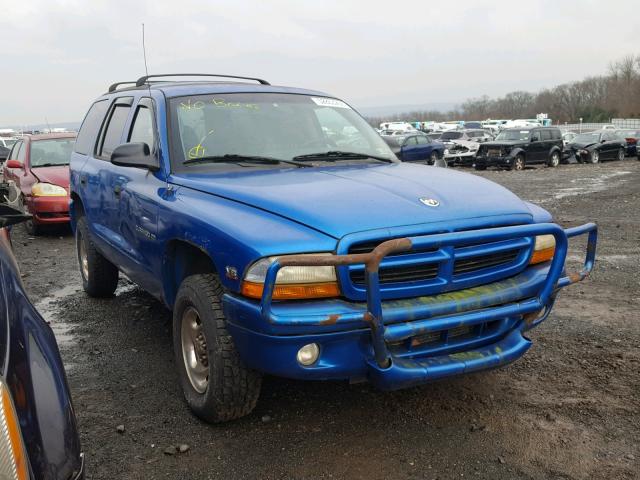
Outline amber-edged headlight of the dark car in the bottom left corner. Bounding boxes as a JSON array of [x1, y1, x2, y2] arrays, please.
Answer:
[[0, 380, 29, 480]]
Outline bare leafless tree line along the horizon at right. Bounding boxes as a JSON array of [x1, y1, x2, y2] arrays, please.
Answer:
[[367, 55, 640, 126]]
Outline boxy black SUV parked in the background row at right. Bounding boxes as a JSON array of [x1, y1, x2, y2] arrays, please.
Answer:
[[475, 127, 563, 170]]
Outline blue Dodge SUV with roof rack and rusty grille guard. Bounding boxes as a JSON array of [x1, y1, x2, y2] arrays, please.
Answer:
[[71, 75, 596, 422]]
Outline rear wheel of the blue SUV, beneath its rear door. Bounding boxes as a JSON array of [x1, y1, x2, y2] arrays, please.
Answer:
[[76, 216, 118, 298]]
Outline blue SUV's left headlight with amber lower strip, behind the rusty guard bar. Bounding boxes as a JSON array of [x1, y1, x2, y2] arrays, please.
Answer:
[[241, 253, 340, 300]]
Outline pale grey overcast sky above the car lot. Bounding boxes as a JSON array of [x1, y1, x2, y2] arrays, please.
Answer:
[[0, 0, 640, 126]]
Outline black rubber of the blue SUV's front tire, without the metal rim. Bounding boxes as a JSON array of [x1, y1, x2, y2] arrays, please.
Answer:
[[173, 273, 262, 423]]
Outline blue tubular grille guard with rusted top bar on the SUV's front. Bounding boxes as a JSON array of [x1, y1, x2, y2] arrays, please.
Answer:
[[260, 223, 598, 369]]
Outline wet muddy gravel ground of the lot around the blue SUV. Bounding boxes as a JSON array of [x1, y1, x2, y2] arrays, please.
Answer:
[[13, 158, 640, 479]]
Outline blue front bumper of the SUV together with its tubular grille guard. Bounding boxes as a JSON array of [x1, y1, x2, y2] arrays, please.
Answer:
[[224, 224, 597, 389]]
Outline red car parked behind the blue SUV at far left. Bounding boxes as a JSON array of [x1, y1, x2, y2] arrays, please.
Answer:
[[3, 133, 76, 235]]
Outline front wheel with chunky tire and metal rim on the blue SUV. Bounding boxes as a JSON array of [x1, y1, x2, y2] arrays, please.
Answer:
[[173, 274, 262, 423]]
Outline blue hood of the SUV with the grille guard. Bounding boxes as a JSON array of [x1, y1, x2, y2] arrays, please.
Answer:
[[170, 163, 531, 238]]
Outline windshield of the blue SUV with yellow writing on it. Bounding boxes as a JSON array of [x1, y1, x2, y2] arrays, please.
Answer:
[[170, 93, 397, 170]]
